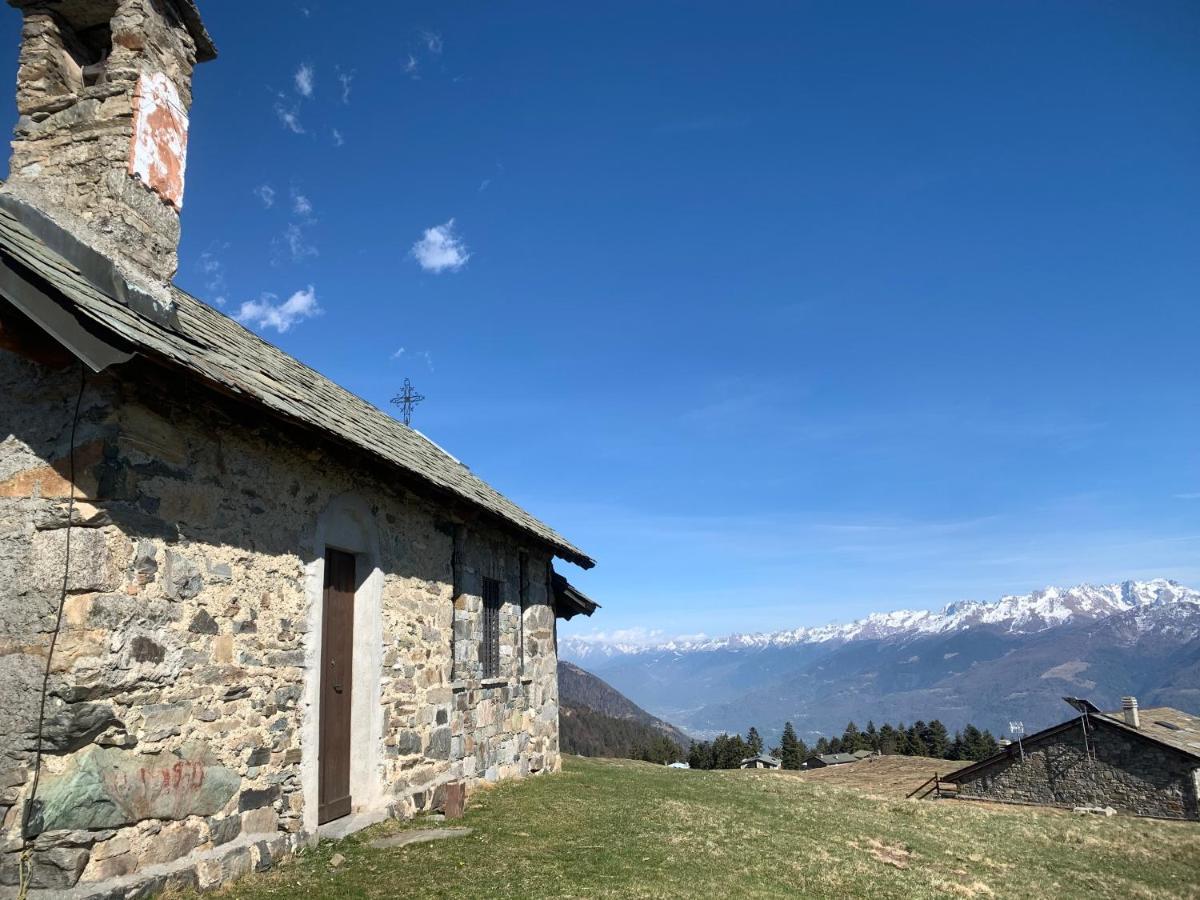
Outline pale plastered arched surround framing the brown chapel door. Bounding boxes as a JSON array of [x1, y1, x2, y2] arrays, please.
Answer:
[[300, 493, 388, 838]]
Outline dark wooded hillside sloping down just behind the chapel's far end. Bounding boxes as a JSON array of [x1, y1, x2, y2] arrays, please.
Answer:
[[558, 661, 691, 762]]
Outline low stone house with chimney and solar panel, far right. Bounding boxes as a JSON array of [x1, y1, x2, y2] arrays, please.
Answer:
[[943, 697, 1200, 820]]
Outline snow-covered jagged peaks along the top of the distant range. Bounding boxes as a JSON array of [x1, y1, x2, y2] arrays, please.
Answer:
[[559, 578, 1200, 661]]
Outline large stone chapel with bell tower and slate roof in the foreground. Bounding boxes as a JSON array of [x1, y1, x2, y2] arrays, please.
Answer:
[[0, 0, 595, 896]]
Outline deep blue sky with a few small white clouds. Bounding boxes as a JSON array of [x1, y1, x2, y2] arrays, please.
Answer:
[[5, 0, 1200, 634]]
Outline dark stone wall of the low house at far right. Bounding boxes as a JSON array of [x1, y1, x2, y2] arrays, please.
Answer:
[[960, 719, 1200, 818]]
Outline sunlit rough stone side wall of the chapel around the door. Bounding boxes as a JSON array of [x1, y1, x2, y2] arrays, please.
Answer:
[[0, 350, 559, 888]]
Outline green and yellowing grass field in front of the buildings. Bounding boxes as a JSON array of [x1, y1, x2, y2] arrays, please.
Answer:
[[184, 757, 1200, 900]]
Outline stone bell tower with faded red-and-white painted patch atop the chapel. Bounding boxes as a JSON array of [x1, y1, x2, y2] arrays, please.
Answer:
[[0, 0, 216, 296]]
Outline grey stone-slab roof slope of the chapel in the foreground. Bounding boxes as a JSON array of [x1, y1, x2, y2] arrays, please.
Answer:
[[0, 208, 595, 569]]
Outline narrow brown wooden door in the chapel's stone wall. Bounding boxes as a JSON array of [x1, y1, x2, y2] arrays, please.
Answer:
[[317, 550, 355, 823]]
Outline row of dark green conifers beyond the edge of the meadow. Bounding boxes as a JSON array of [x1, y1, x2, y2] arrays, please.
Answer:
[[688, 719, 1000, 769]]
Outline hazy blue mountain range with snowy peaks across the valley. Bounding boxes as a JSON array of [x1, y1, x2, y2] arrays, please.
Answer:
[[559, 578, 1200, 739]]
